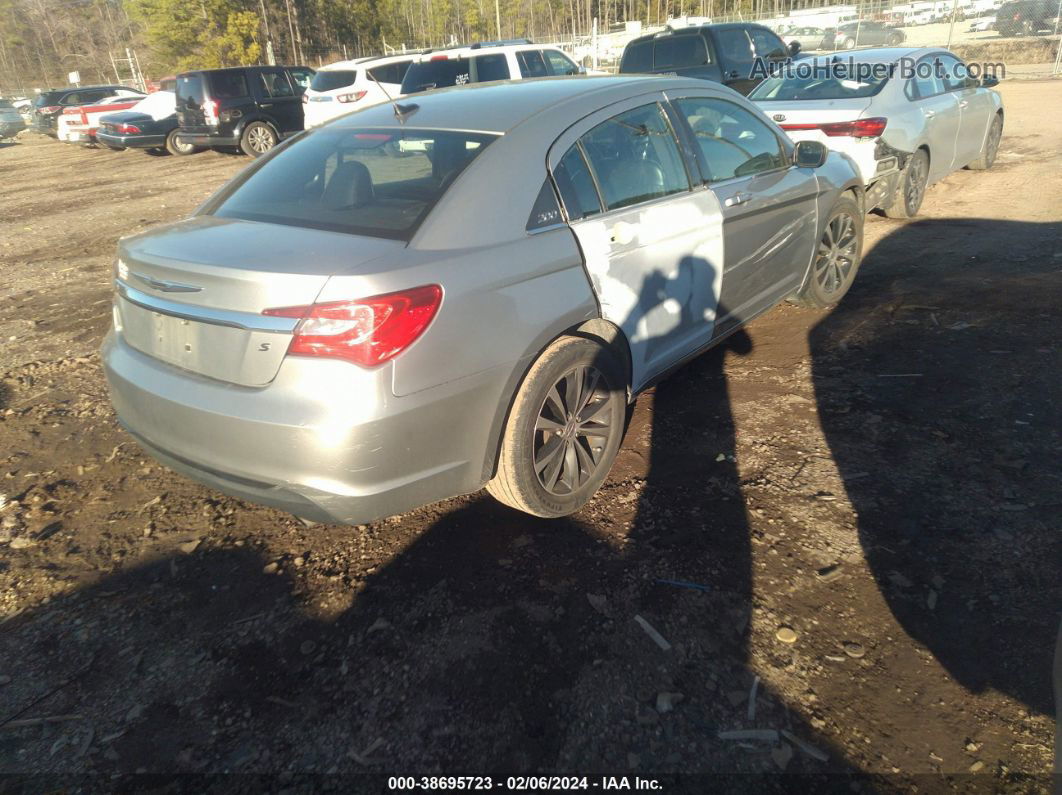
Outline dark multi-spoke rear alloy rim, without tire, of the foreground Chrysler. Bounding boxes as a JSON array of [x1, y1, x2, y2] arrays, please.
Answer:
[[534, 365, 621, 496]]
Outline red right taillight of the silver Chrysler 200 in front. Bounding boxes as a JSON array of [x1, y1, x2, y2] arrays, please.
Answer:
[[262, 284, 443, 367]]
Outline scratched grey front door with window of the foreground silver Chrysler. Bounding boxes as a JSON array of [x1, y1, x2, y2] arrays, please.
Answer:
[[668, 91, 818, 334]]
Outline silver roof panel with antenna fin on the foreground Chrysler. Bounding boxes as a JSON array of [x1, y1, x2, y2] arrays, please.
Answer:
[[331, 74, 720, 134]]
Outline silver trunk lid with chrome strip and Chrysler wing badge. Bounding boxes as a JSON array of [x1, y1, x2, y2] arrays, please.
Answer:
[[115, 215, 405, 386]]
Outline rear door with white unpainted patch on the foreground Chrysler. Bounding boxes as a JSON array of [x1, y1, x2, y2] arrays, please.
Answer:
[[549, 94, 723, 390]]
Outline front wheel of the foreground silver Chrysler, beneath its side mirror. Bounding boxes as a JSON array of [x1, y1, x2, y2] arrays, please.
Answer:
[[792, 194, 863, 309]]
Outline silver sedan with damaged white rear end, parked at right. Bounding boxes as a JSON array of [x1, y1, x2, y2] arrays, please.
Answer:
[[749, 48, 1004, 218]]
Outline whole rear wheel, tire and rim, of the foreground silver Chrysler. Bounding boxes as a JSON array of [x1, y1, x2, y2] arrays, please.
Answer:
[[486, 336, 627, 518]]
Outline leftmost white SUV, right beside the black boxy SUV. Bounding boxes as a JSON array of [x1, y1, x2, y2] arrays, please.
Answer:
[[303, 53, 413, 128]]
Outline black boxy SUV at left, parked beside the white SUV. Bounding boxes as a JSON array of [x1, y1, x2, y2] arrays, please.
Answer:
[[176, 66, 314, 157]]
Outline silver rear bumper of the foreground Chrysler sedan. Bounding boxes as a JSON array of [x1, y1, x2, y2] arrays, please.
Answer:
[[102, 331, 509, 524]]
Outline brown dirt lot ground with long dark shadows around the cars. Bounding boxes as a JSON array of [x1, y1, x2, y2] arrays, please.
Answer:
[[0, 81, 1062, 792]]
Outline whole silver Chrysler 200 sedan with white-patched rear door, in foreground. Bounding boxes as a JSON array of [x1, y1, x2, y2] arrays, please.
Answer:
[[103, 76, 863, 523]]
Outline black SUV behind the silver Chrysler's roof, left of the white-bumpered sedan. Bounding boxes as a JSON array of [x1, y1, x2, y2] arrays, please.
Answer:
[[619, 22, 800, 94]]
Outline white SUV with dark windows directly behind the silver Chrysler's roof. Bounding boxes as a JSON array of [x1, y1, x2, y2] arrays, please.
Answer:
[[401, 38, 583, 94]]
